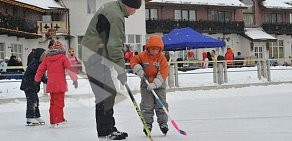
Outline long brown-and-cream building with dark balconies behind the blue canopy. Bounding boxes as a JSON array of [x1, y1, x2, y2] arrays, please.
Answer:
[[145, 0, 292, 62]]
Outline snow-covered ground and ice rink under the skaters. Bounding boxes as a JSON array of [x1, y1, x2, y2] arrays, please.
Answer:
[[0, 67, 292, 141]]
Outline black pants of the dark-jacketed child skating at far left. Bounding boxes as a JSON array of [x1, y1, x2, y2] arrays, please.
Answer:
[[24, 90, 41, 118]]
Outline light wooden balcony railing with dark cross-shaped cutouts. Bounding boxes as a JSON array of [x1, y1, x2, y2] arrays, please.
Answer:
[[37, 21, 68, 34]]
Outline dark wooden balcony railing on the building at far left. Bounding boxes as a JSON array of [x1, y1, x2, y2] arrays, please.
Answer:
[[0, 14, 41, 39]]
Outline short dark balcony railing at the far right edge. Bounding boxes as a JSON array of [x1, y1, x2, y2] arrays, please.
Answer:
[[262, 23, 292, 35]]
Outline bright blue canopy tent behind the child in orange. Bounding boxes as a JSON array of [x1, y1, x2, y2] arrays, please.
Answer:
[[162, 27, 225, 51]]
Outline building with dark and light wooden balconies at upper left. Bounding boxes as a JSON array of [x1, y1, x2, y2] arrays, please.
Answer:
[[0, 0, 69, 64]]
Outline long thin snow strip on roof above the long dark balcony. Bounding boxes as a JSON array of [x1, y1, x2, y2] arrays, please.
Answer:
[[150, 0, 246, 7]]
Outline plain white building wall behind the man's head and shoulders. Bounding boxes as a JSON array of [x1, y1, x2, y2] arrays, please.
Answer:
[[63, 0, 146, 51]]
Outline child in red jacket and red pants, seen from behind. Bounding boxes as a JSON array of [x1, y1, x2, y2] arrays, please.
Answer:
[[34, 41, 78, 128]]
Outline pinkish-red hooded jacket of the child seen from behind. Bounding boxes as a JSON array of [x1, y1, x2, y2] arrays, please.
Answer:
[[34, 54, 78, 93]]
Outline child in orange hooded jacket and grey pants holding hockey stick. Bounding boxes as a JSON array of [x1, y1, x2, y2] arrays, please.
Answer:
[[130, 35, 168, 135]]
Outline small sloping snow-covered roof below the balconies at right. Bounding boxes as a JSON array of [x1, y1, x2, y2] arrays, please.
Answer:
[[244, 28, 277, 41]]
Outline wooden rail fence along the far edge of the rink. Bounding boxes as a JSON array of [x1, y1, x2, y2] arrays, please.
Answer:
[[0, 59, 292, 90]]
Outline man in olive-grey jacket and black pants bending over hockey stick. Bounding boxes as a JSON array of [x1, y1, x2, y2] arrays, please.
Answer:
[[81, 0, 141, 140]]
